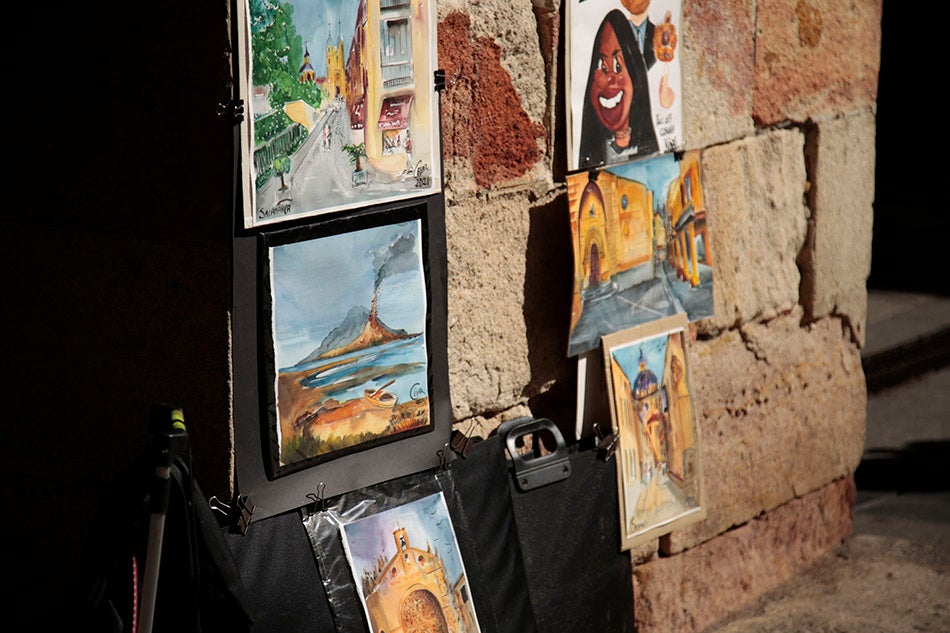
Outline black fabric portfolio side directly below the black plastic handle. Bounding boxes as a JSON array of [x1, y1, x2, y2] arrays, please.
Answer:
[[509, 448, 635, 633]]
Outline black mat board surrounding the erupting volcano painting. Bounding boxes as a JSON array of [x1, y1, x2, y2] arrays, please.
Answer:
[[232, 195, 452, 520]]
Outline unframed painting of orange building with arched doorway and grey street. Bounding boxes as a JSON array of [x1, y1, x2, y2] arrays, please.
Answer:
[[567, 151, 713, 356]]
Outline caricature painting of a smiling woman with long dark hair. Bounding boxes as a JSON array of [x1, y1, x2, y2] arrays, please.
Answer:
[[565, 0, 683, 171]]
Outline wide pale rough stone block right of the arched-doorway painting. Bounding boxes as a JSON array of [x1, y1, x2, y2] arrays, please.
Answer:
[[699, 130, 808, 333]]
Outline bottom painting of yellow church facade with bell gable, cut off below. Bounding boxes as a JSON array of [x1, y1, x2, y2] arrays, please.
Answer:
[[341, 492, 480, 633]]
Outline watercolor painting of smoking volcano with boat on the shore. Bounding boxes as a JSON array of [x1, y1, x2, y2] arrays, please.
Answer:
[[268, 220, 431, 467]]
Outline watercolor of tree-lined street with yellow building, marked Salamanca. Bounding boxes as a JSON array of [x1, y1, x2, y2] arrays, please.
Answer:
[[239, 0, 441, 228]]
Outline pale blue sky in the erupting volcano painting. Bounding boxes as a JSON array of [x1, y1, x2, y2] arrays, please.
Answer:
[[271, 220, 426, 367]]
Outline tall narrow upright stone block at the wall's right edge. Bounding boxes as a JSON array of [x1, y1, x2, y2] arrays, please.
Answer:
[[799, 111, 876, 345]]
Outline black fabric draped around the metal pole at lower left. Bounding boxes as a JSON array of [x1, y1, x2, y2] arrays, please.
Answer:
[[76, 451, 251, 633]]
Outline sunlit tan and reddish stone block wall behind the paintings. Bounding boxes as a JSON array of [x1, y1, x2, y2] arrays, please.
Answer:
[[438, 0, 882, 633]]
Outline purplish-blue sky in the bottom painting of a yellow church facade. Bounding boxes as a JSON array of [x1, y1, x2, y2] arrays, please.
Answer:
[[343, 493, 462, 583]]
